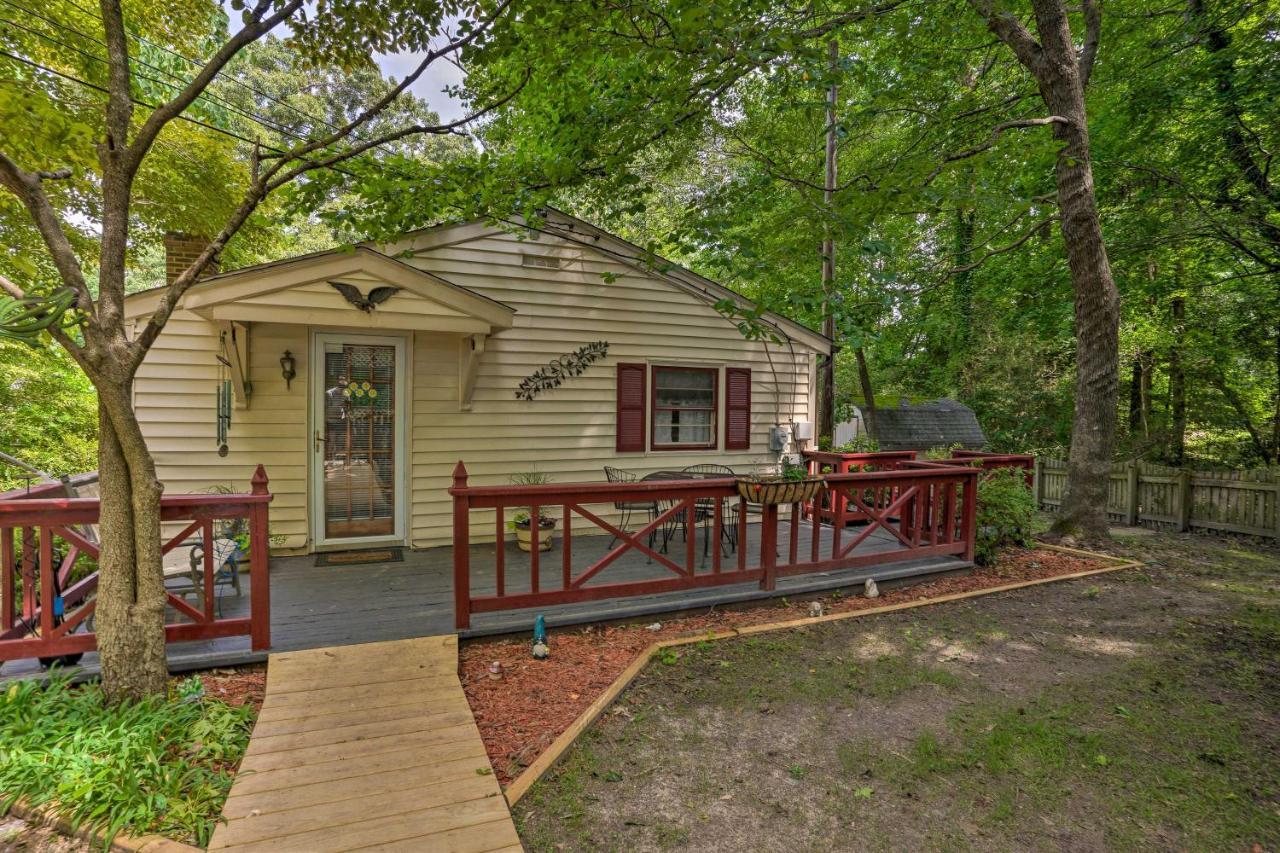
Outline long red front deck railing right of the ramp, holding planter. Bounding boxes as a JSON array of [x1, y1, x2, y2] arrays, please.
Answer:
[[449, 462, 978, 629]]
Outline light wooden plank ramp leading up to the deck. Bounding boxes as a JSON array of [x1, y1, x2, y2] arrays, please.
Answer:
[[209, 635, 522, 853]]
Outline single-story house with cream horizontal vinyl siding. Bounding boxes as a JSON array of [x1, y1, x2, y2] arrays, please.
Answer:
[[128, 213, 829, 551]]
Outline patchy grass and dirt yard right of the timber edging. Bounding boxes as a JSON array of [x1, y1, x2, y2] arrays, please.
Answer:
[[515, 535, 1280, 853]]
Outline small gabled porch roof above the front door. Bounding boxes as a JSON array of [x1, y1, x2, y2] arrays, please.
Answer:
[[125, 246, 516, 332]]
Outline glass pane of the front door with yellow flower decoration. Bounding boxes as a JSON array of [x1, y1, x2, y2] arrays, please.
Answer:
[[319, 341, 401, 539]]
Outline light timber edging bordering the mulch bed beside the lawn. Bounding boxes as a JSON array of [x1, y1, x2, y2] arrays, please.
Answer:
[[503, 543, 1143, 807]]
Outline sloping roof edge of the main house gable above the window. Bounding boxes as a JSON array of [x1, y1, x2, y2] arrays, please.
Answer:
[[373, 207, 835, 353]]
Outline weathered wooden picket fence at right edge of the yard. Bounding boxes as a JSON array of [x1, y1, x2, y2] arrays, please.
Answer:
[[1034, 459, 1280, 539]]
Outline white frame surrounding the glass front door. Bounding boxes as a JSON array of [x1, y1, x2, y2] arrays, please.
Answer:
[[307, 332, 410, 549]]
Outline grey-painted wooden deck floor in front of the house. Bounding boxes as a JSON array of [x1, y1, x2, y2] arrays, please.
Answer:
[[0, 524, 970, 683]]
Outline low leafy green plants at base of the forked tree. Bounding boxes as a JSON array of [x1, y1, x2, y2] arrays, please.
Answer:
[[0, 674, 253, 847]]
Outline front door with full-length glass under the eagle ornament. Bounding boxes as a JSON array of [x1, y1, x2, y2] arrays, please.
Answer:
[[312, 333, 407, 544]]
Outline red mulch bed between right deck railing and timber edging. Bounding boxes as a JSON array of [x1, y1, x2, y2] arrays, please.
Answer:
[[460, 549, 1107, 785]]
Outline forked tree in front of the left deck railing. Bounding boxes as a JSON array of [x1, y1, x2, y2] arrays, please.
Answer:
[[0, 0, 515, 699]]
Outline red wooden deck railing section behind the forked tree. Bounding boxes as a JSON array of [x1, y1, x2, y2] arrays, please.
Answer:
[[0, 465, 271, 661]]
